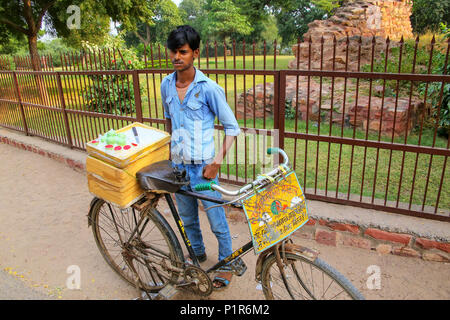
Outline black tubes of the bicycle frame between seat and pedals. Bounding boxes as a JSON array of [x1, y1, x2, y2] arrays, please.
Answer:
[[165, 190, 253, 273]]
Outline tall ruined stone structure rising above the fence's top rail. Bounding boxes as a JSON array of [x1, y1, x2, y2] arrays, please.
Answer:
[[289, 0, 413, 71]]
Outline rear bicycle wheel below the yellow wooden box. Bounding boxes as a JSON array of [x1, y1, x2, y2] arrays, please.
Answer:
[[90, 199, 183, 292]]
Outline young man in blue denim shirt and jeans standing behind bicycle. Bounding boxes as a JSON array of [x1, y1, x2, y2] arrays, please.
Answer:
[[161, 25, 242, 288]]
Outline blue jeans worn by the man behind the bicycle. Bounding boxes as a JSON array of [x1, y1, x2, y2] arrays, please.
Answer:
[[175, 161, 233, 261]]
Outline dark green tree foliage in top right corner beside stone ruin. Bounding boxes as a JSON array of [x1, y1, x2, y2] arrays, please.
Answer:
[[411, 0, 450, 34]]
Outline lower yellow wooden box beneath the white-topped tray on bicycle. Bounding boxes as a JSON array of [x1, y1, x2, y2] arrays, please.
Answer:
[[86, 144, 169, 208]]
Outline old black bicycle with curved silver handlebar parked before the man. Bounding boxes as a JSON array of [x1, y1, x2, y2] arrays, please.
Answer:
[[88, 148, 364, 300]]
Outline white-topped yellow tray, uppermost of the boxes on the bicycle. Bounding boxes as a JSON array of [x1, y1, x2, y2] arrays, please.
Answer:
[[86, 122, 170, 168]]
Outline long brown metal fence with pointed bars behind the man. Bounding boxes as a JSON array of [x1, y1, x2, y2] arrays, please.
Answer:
[[0, 37, 450, 221]]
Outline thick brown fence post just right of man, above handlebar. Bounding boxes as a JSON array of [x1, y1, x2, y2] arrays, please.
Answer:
[[273, 71, 286, 162]]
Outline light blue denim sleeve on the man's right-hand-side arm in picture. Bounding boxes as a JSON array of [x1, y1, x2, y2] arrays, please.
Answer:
[[206, 82, 241, 136]]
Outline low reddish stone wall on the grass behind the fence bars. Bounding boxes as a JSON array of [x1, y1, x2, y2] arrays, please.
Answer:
[[236, 76, 424, 137]]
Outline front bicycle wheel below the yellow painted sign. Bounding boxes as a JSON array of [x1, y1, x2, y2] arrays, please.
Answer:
[[261, 253, 364, 300]]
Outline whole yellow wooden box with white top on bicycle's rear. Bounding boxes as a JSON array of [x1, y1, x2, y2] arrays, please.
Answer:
[[86, 122, 170, 208]]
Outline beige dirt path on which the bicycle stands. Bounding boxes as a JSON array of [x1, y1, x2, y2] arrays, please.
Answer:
[[0, 144, 450, 300]]
